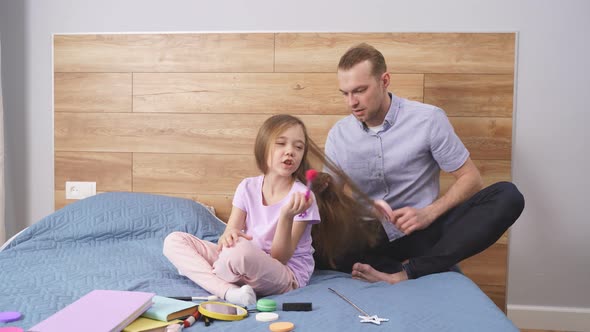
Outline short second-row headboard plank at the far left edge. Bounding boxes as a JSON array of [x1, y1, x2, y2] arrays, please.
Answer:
[[54, 73, 132, 112]]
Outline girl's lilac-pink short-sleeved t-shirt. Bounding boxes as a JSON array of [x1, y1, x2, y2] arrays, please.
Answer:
[[233, 175, 320, 287]]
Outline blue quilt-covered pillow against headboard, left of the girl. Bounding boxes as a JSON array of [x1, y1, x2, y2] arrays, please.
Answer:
[[7, 192, 225, 252]]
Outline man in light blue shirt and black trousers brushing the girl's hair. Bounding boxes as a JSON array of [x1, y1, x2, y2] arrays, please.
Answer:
[[325, 43, 524, 284]]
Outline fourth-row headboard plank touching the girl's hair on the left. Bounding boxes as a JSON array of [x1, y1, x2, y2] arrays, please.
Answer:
[[133, 153, 260, 195]]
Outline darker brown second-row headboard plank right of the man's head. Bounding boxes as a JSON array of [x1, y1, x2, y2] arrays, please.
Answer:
[[424, 74, 514, 118]]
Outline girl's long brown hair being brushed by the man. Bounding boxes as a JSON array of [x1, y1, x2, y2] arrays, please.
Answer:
[[254, 114, 382, 271]]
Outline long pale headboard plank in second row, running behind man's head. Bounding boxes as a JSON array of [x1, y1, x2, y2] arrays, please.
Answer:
[[133, 73, 424, 115]]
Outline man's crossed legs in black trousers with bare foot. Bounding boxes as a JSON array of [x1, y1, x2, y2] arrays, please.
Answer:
[[352, 182, 524, 284]]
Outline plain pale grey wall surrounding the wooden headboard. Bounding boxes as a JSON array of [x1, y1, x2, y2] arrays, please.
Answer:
[[0, 0, 590, 330]]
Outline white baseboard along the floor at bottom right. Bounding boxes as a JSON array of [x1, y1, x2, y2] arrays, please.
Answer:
[[507, 304, 590, 332]]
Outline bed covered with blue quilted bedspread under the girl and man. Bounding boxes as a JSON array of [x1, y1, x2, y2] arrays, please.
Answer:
[[0, 193, 518, 331]]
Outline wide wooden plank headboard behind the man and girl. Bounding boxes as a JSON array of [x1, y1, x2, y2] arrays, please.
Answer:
[[53, 33, 516, 309]]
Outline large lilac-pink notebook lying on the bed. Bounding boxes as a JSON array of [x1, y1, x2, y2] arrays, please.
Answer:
[[27, 290, 155, 332]]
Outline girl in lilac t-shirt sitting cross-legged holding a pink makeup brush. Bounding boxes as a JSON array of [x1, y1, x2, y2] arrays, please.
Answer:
[[164, 115, 320, 306]]
